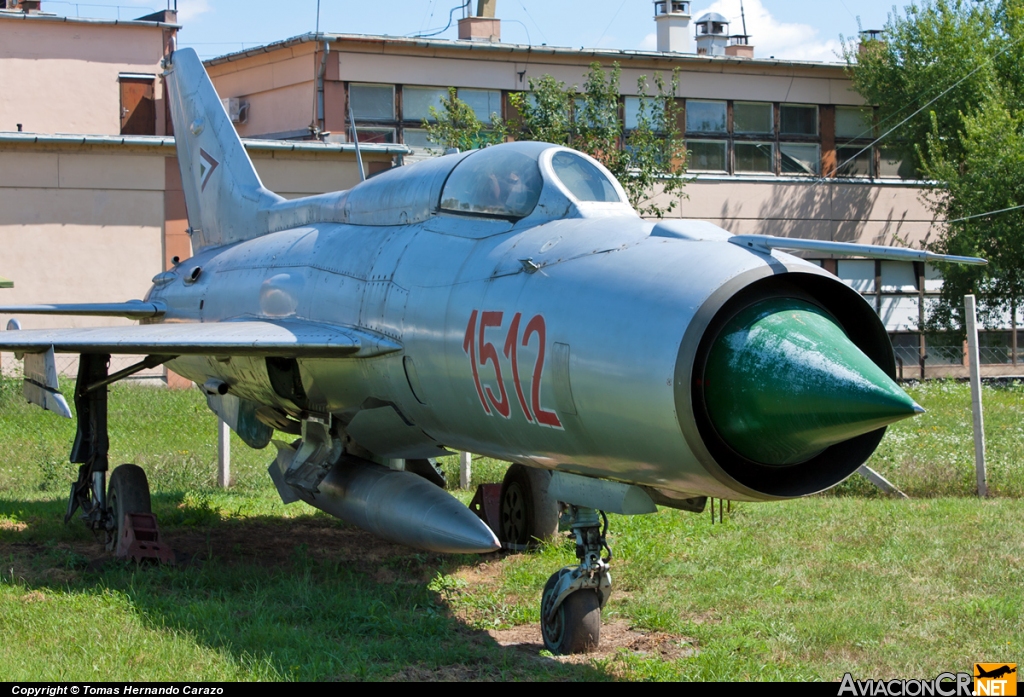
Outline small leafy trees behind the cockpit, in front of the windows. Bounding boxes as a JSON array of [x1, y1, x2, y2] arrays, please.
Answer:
[[425, 62, 688, 218]]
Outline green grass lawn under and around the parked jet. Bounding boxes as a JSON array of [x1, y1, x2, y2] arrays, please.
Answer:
[[0, 380, 1024, 681]]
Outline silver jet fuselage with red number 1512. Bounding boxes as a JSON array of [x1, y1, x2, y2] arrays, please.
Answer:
[[147, 214, 835, 499]]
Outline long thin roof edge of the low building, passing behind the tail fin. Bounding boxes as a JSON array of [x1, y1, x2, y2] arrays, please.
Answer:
[[0, 131, 413, 155]]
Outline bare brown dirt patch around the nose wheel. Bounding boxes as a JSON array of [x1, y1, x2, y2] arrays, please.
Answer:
[[487, 620, 697, 663]]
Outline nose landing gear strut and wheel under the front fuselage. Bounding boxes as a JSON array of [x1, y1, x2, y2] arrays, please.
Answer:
[[541, 506, 611, 654]]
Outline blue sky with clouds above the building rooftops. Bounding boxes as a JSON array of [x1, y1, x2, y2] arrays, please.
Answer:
[[43, 0, 908, 60]]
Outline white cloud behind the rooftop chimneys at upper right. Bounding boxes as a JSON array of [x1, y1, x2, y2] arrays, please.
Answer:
[[640, 0, 843, 62]]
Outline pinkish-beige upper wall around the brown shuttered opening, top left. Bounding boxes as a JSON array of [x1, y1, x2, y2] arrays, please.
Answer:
[[0, 15, 165, 135]]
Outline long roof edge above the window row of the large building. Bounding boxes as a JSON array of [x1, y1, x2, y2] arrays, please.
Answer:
[[203, 32, 846, 71]]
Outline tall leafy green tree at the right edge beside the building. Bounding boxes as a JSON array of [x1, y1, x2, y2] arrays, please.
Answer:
[[846, 0, 1024, 333]]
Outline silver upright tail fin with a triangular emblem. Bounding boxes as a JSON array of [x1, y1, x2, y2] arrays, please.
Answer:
[[166, 48, 284, 251]]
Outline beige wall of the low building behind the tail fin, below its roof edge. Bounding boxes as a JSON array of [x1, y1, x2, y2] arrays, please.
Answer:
[[0, 143, 382, 376]]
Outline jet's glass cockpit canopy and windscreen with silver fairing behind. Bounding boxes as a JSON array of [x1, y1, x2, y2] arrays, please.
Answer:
[[339, 141, 636, 225]]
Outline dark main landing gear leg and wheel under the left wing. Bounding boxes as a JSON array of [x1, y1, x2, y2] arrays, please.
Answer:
[[65, 353, 167, 558]]
